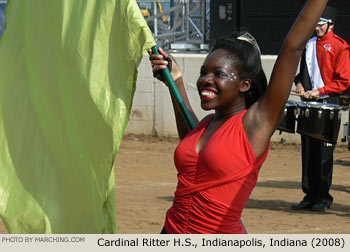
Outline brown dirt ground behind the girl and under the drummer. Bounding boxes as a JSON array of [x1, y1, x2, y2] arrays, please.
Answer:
[[0, 136, 350, 234]]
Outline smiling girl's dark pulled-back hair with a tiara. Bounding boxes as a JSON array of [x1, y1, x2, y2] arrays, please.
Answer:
[[210, 30, 267, 108]]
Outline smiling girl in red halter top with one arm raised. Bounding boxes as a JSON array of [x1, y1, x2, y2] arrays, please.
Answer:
[[149, 0, 327, 234]]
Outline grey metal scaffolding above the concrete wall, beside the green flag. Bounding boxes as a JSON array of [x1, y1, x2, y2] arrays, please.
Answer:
[[137, 0, 209, 49]]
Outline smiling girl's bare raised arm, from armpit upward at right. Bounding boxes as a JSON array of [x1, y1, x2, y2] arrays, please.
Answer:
[[243, 0, 328, 157]]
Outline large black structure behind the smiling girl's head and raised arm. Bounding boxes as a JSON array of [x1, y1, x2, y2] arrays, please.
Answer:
[[210, 0, 350, 55]]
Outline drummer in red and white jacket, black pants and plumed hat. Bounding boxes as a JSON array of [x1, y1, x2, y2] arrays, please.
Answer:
[[292, 7, 350, 211]]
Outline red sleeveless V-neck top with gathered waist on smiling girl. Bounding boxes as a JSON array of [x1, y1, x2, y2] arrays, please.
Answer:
[[165, 110, 268, 234]]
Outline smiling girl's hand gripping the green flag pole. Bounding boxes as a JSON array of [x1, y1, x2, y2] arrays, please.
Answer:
[[148, 48, 182, 85]]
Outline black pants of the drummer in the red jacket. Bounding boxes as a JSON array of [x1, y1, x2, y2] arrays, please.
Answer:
[[301, 134, 335, 206]]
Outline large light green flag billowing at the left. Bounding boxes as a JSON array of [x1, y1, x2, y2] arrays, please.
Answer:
[[0, 0, 155, 233]]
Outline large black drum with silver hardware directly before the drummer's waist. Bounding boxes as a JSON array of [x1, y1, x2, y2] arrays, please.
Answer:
[[297, 102, 342, 143]]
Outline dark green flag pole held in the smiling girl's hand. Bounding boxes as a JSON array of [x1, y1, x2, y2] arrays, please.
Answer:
[[152, 45, 196, 130]]
